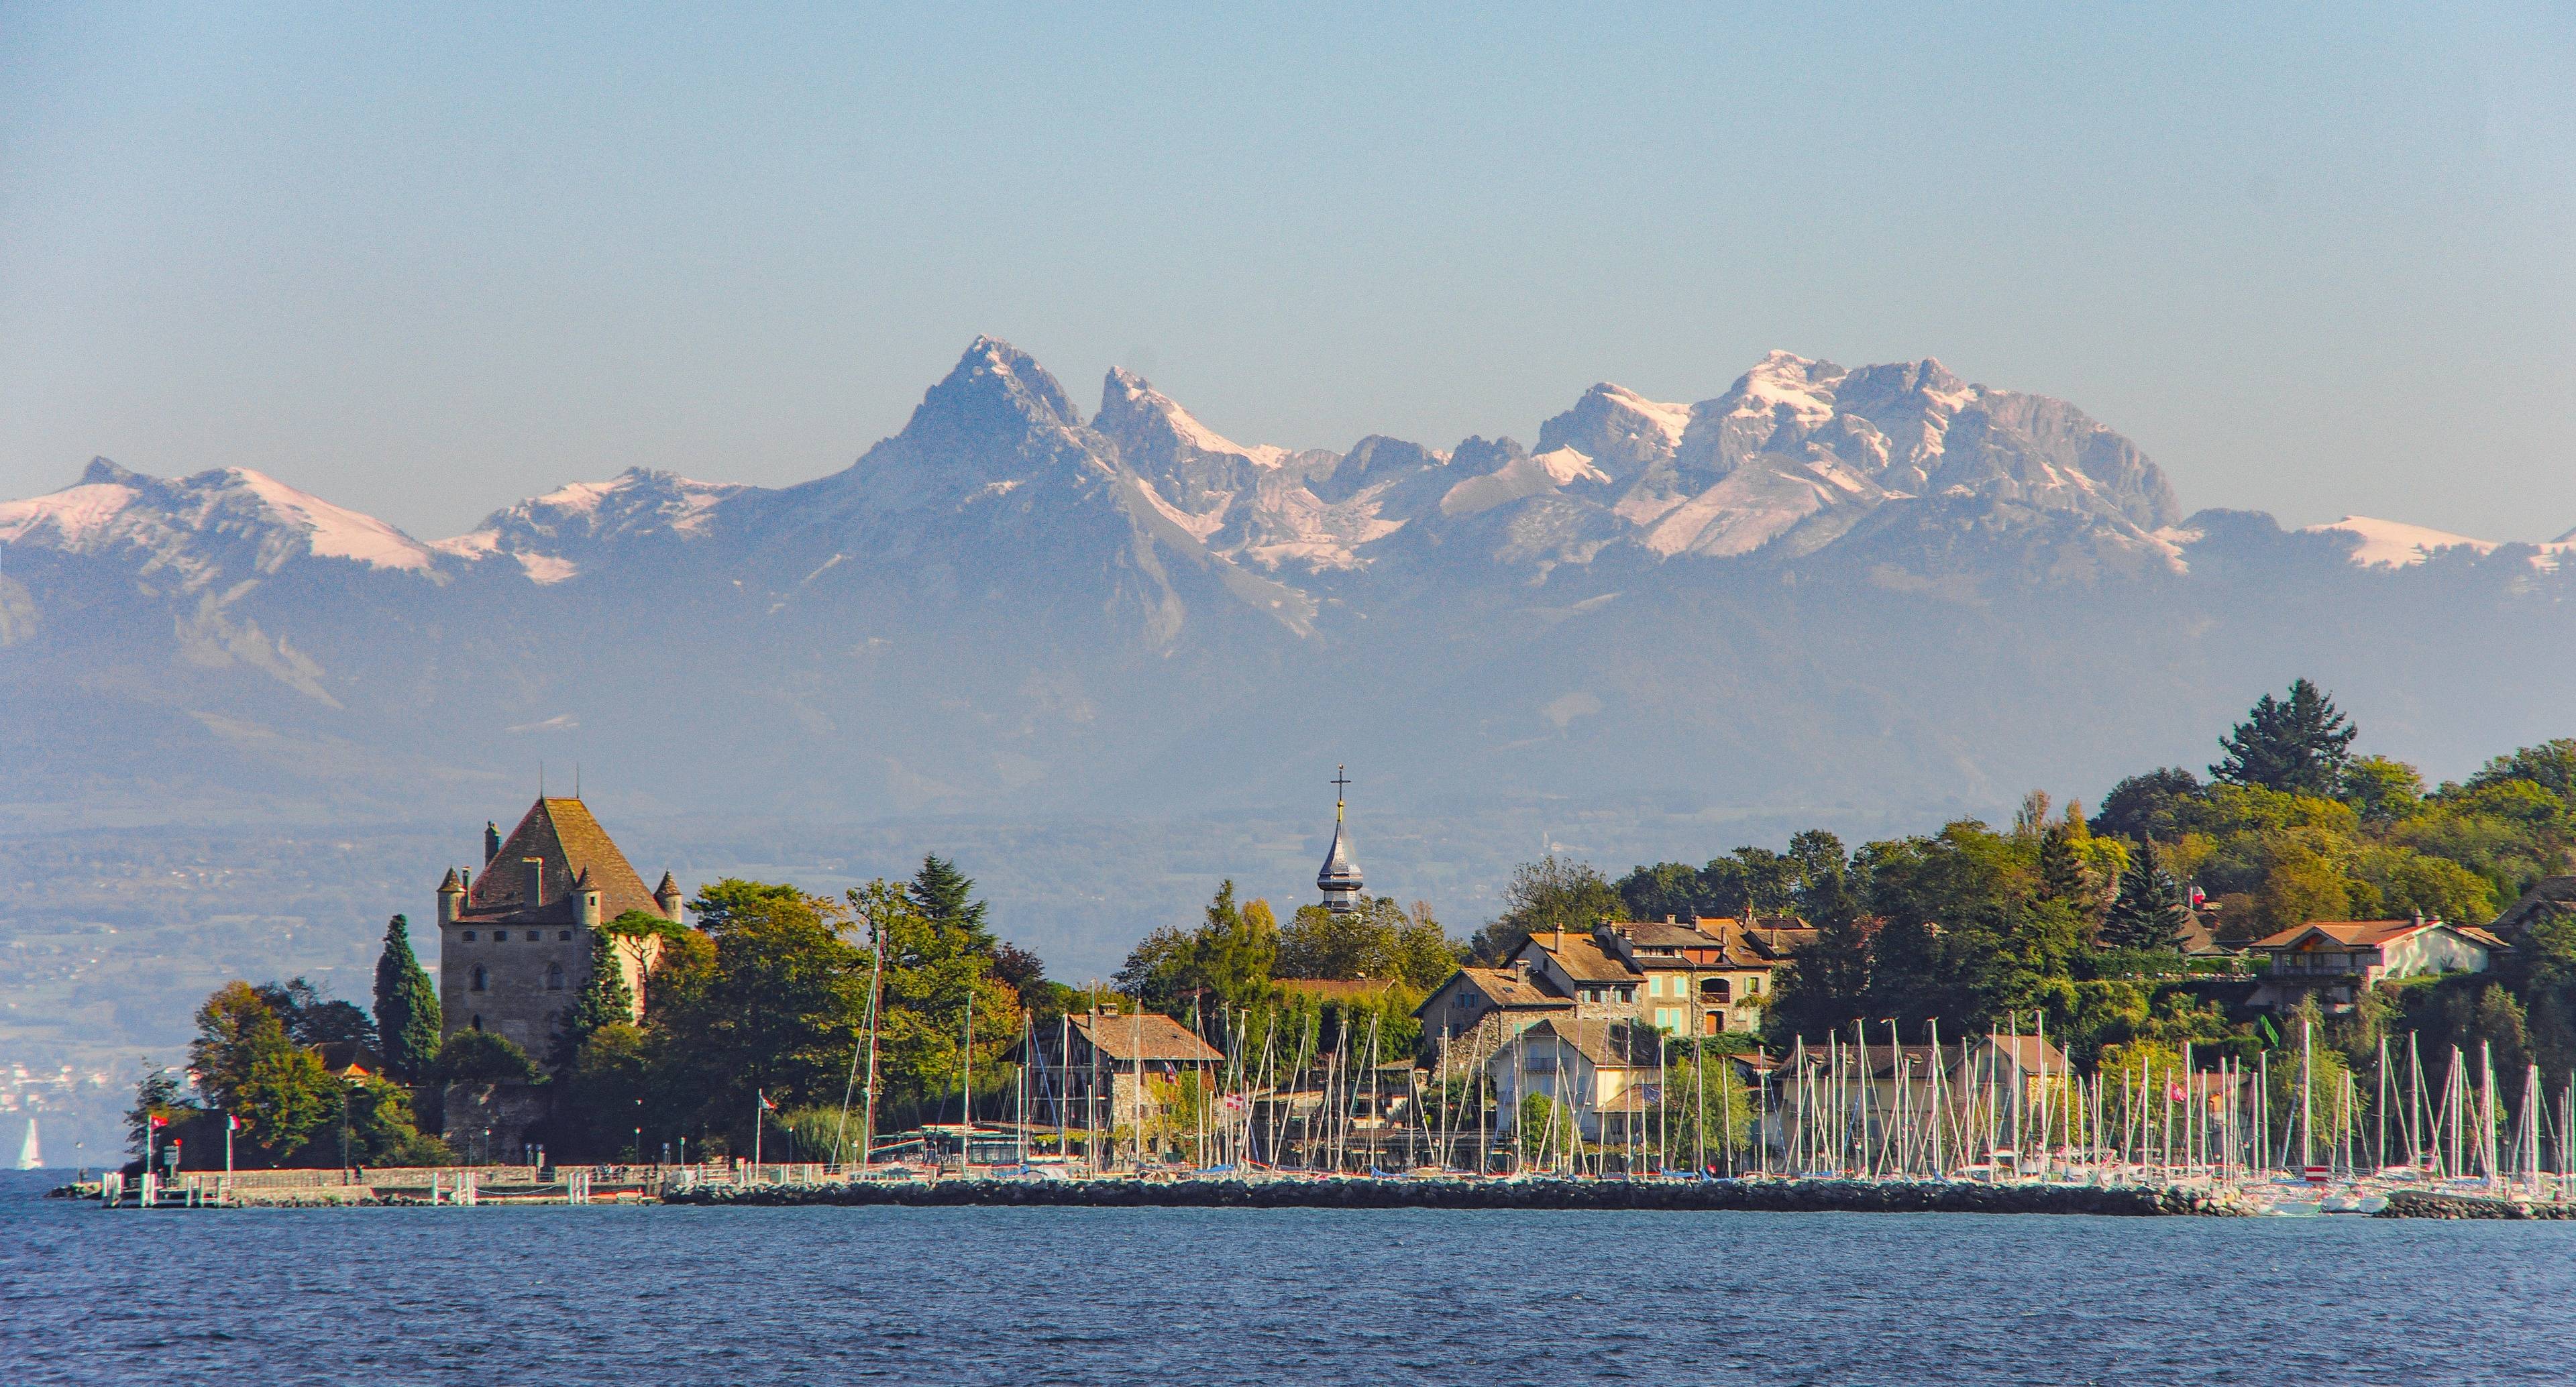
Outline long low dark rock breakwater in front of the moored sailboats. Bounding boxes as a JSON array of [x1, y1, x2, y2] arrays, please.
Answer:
[[662, 1178, 2246, 1217]]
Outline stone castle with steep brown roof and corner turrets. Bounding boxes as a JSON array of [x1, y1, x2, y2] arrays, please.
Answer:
[[438, 797, 680, 1160]]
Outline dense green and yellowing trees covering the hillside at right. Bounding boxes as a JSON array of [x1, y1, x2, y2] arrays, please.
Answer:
[[1607, 679, 2576, 1101]]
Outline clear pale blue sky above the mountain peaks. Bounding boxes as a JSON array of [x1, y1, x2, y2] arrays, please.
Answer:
[[0, 0, 2576, 541]]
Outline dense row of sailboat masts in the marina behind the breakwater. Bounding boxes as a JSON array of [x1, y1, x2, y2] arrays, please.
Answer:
[[783, 993, 2576, 1202]]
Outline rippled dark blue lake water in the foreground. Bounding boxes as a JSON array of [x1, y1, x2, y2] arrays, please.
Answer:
[[0, 1174, 2576, 1387]]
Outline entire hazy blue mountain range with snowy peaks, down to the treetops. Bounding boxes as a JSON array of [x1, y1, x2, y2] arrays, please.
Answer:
[[0, 337, 2576, 838]]
